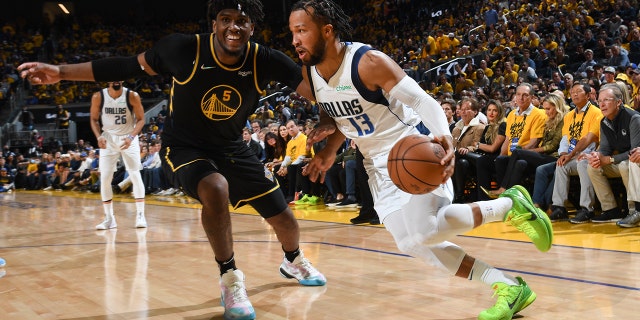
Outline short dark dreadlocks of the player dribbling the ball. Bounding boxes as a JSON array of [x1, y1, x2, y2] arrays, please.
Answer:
[[291, 0, 353, 40]]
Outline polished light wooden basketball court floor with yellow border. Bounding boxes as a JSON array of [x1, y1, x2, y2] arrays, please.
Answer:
[[0, 191, 640, 320]]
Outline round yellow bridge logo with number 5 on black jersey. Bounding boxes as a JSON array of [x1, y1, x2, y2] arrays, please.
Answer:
[[200, 85, 242, 121]]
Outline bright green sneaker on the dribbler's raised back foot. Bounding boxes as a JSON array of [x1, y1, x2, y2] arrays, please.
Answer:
[[500, 185, 553, 252]]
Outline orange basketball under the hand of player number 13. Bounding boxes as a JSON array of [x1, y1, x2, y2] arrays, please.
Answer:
[[387, 134, 445, 194]]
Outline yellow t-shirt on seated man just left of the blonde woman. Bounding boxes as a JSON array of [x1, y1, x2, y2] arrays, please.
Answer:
[[506, 105, 547, 155]]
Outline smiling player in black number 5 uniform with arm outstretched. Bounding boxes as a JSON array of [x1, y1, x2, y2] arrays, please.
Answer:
[[18, 0, 326, 319]]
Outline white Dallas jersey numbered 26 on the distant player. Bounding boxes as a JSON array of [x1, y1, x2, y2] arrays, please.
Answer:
[[101, 88, 136, 136]]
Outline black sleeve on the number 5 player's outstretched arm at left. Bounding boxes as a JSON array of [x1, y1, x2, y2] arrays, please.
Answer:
[[91, 56, 149, 82]]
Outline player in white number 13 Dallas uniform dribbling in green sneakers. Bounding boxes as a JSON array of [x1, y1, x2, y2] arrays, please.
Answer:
[[289, 0, 552, 320]]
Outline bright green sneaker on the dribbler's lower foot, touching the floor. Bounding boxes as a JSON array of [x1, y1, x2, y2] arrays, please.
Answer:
[[478, 277, 536, 320]]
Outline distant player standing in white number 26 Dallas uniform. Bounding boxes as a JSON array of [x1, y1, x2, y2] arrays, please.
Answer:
[[91, 81, 147, 230]]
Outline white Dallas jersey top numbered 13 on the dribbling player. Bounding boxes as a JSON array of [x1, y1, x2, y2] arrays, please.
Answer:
[[310, 42, 422, 158]]
